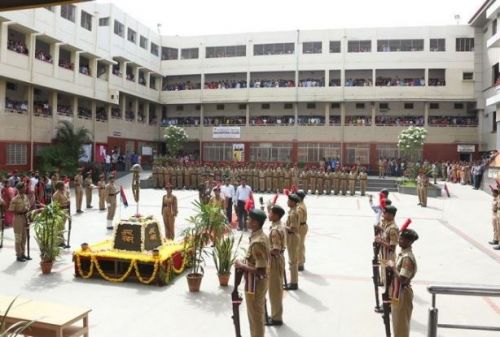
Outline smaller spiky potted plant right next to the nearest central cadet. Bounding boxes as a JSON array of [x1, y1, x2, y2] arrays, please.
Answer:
[[212, 235, 242, 287]]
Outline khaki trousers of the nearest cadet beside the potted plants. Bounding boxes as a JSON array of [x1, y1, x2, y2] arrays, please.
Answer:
[[245, 278, 268, 337]]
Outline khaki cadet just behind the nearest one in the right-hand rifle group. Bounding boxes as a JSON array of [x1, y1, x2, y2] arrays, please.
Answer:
[[375, 205, 399, 284]]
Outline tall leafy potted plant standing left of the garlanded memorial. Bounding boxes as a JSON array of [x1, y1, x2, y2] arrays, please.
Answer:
[[33, 203, 68, 274]]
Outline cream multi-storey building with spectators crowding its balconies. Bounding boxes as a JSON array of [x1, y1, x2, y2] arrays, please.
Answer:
[[0, 3, 484, 168]]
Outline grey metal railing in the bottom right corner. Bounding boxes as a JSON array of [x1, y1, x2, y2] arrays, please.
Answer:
[[427, 285, 500, 337]]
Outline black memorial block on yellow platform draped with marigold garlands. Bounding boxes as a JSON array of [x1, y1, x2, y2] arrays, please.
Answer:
[[73, 217, 187, 286]]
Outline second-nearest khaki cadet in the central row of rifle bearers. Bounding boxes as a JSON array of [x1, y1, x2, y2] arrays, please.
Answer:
[[266, 205, 286, 325]]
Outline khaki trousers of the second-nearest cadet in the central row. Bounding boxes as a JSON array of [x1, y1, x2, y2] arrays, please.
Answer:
[[269, 254, 285, 321]]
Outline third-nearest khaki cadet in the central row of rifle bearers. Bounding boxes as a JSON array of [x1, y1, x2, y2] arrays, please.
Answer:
[[285, 193, 300, 290]]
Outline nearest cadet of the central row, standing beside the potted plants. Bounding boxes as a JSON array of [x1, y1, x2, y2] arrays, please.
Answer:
[[235, 209, 269, 337]]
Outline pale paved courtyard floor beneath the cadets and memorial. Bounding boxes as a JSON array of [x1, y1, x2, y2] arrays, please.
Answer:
[[0, 173, 500, 337]]
